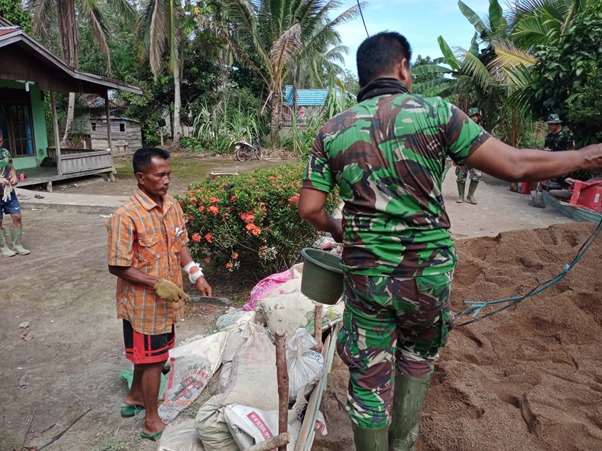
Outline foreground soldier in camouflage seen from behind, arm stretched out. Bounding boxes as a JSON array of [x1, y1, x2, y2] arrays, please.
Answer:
[[299, 32, 602, 451]]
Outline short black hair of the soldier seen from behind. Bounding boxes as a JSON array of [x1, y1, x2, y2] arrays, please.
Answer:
[[357, 31, 412, 88]]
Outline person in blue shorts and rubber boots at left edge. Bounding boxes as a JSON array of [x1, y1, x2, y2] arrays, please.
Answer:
[[0, 130, 29, 257]]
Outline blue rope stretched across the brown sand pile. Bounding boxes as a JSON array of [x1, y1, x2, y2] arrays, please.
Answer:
[[454, 219, 602, 327]]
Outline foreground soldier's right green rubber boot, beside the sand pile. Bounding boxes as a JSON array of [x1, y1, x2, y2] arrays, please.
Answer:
[[389, 372, 429, 451]]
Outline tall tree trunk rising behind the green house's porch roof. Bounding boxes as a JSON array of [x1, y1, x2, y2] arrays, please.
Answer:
[[57, 0, 78, 147]]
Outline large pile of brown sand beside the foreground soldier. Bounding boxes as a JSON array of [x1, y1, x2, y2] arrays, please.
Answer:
[[314, 224, 602, 451]]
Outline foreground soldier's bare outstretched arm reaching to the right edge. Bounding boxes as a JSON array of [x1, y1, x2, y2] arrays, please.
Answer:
[[466, 137, 602, 182]]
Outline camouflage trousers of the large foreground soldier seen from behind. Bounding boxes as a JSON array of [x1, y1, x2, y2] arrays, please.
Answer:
[[337, 272, 453, 428]]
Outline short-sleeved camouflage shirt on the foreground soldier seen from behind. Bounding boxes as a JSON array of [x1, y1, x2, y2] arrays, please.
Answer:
[[303, 92, 490, 277]]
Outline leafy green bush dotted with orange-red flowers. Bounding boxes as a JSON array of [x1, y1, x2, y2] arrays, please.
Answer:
[[180, 163, 337, 276]]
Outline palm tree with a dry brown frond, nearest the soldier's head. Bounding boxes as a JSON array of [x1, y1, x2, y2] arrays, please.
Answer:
[[223, 0, 359, 141]]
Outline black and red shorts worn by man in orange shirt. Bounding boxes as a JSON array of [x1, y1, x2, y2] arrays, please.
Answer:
[[123, 320, 176, 364]]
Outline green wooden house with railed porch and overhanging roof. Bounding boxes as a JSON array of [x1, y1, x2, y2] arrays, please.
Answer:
[[0, 18, 142, 190]]
